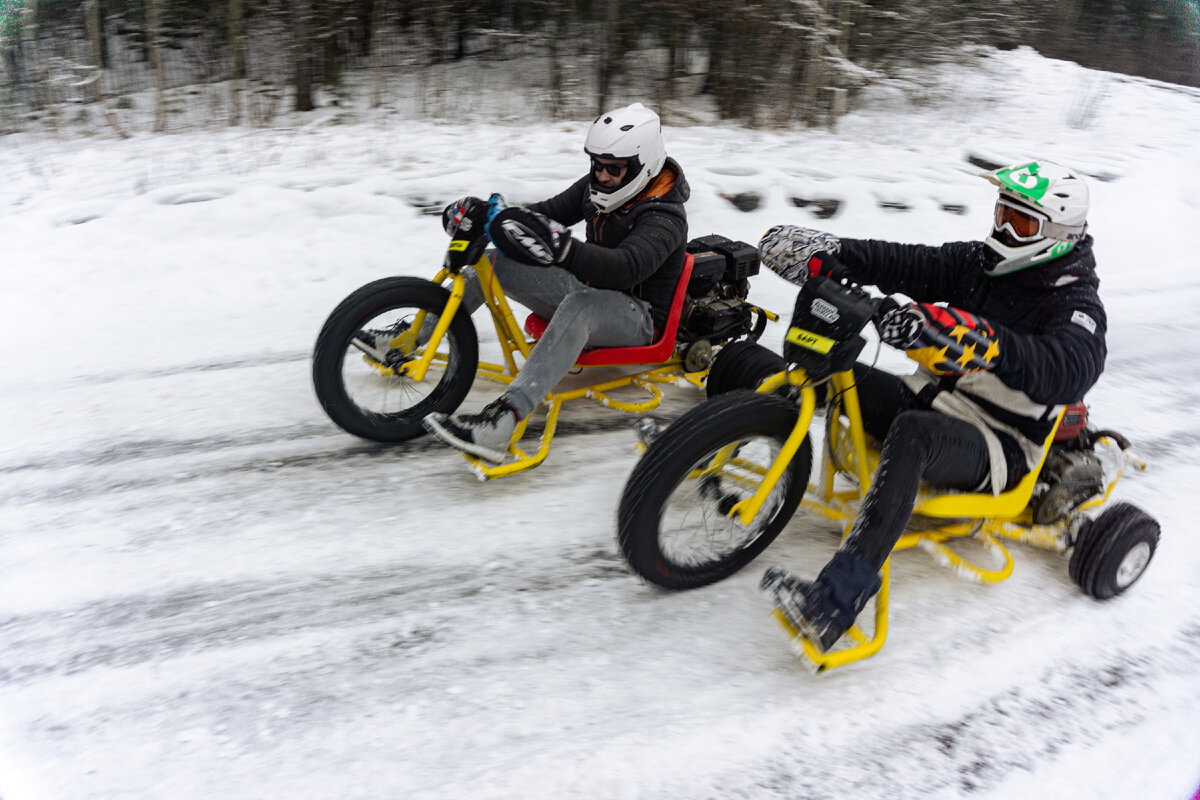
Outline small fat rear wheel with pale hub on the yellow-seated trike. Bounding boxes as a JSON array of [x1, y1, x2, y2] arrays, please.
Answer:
[[1067, 503, 1160, 600]]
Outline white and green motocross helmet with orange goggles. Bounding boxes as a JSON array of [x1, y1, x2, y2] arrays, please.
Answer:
[[983, 161, 1088, 275]]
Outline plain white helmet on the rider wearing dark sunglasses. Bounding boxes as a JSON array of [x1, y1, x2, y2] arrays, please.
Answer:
[[583, 103, 667, 213]]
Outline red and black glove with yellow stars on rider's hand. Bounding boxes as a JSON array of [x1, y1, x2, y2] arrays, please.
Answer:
[[875, 302, 1000, 375]]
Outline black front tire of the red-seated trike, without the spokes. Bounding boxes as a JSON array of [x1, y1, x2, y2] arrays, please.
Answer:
[[312, 277, 479, 443]]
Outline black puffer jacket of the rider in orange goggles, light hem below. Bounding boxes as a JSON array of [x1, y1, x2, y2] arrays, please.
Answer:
[[840, 236, 1108, 493]]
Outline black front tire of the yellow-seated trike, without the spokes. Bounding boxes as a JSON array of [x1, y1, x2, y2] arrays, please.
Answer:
[[617, 390, 812, 589]]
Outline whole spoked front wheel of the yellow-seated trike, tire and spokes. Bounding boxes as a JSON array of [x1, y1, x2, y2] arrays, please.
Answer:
[[617, 390, 812, 589]]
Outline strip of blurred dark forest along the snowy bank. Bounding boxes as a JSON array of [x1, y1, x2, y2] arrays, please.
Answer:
[[0, 0, 1200, 136]]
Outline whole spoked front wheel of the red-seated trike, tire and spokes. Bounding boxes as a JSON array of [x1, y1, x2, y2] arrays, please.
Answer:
[[312, 277, 479, 443]]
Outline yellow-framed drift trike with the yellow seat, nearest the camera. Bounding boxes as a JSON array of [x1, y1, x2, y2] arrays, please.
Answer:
[[618, 277, 1159, 672]]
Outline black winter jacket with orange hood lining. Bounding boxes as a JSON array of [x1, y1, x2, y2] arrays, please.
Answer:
[[529, 158, 691, 326]]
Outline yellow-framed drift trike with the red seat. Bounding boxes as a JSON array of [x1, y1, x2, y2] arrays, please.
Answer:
[[312, 206, 778, 480]]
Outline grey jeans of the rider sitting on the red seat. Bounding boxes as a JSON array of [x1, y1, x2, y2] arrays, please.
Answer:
[[463, 253, 654, 417]]
